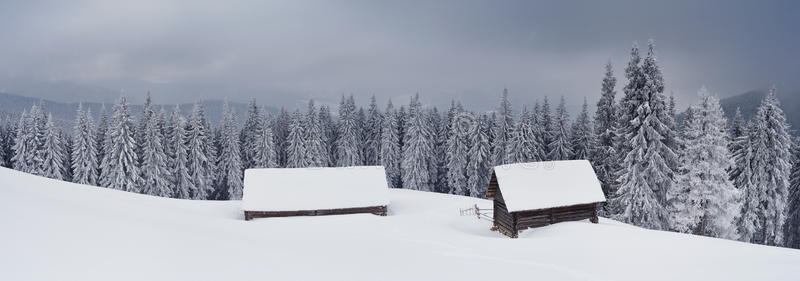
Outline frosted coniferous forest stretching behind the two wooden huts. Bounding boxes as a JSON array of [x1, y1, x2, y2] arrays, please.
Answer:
[[0, 40, 800, 248]]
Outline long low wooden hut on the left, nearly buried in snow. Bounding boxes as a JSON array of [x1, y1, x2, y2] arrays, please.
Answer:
[[242, 166, 389, 220]]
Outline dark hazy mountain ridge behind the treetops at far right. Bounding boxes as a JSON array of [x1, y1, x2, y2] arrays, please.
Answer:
[[720, 90, 800, 135]]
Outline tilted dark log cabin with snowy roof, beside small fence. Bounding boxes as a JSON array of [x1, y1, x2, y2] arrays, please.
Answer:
[[486, 160, 606, 238]]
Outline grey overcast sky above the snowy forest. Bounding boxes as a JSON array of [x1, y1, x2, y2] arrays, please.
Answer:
[[0, 0, 800, 110]]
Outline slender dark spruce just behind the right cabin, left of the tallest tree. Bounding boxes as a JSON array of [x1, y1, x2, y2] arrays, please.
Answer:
[[590, 62, 619, 201]]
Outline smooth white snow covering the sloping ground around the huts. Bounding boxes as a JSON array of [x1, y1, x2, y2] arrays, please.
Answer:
[[0, 168, 800, 281]]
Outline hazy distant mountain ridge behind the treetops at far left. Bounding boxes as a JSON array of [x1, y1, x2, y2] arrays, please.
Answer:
[[0, 92, 279, 125]]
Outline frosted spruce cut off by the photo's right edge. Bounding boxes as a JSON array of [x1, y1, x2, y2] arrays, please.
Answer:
[[783, 142, 800, 249]]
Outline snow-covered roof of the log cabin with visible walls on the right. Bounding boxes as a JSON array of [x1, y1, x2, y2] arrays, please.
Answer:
[[494, 160, 606, 212]]
